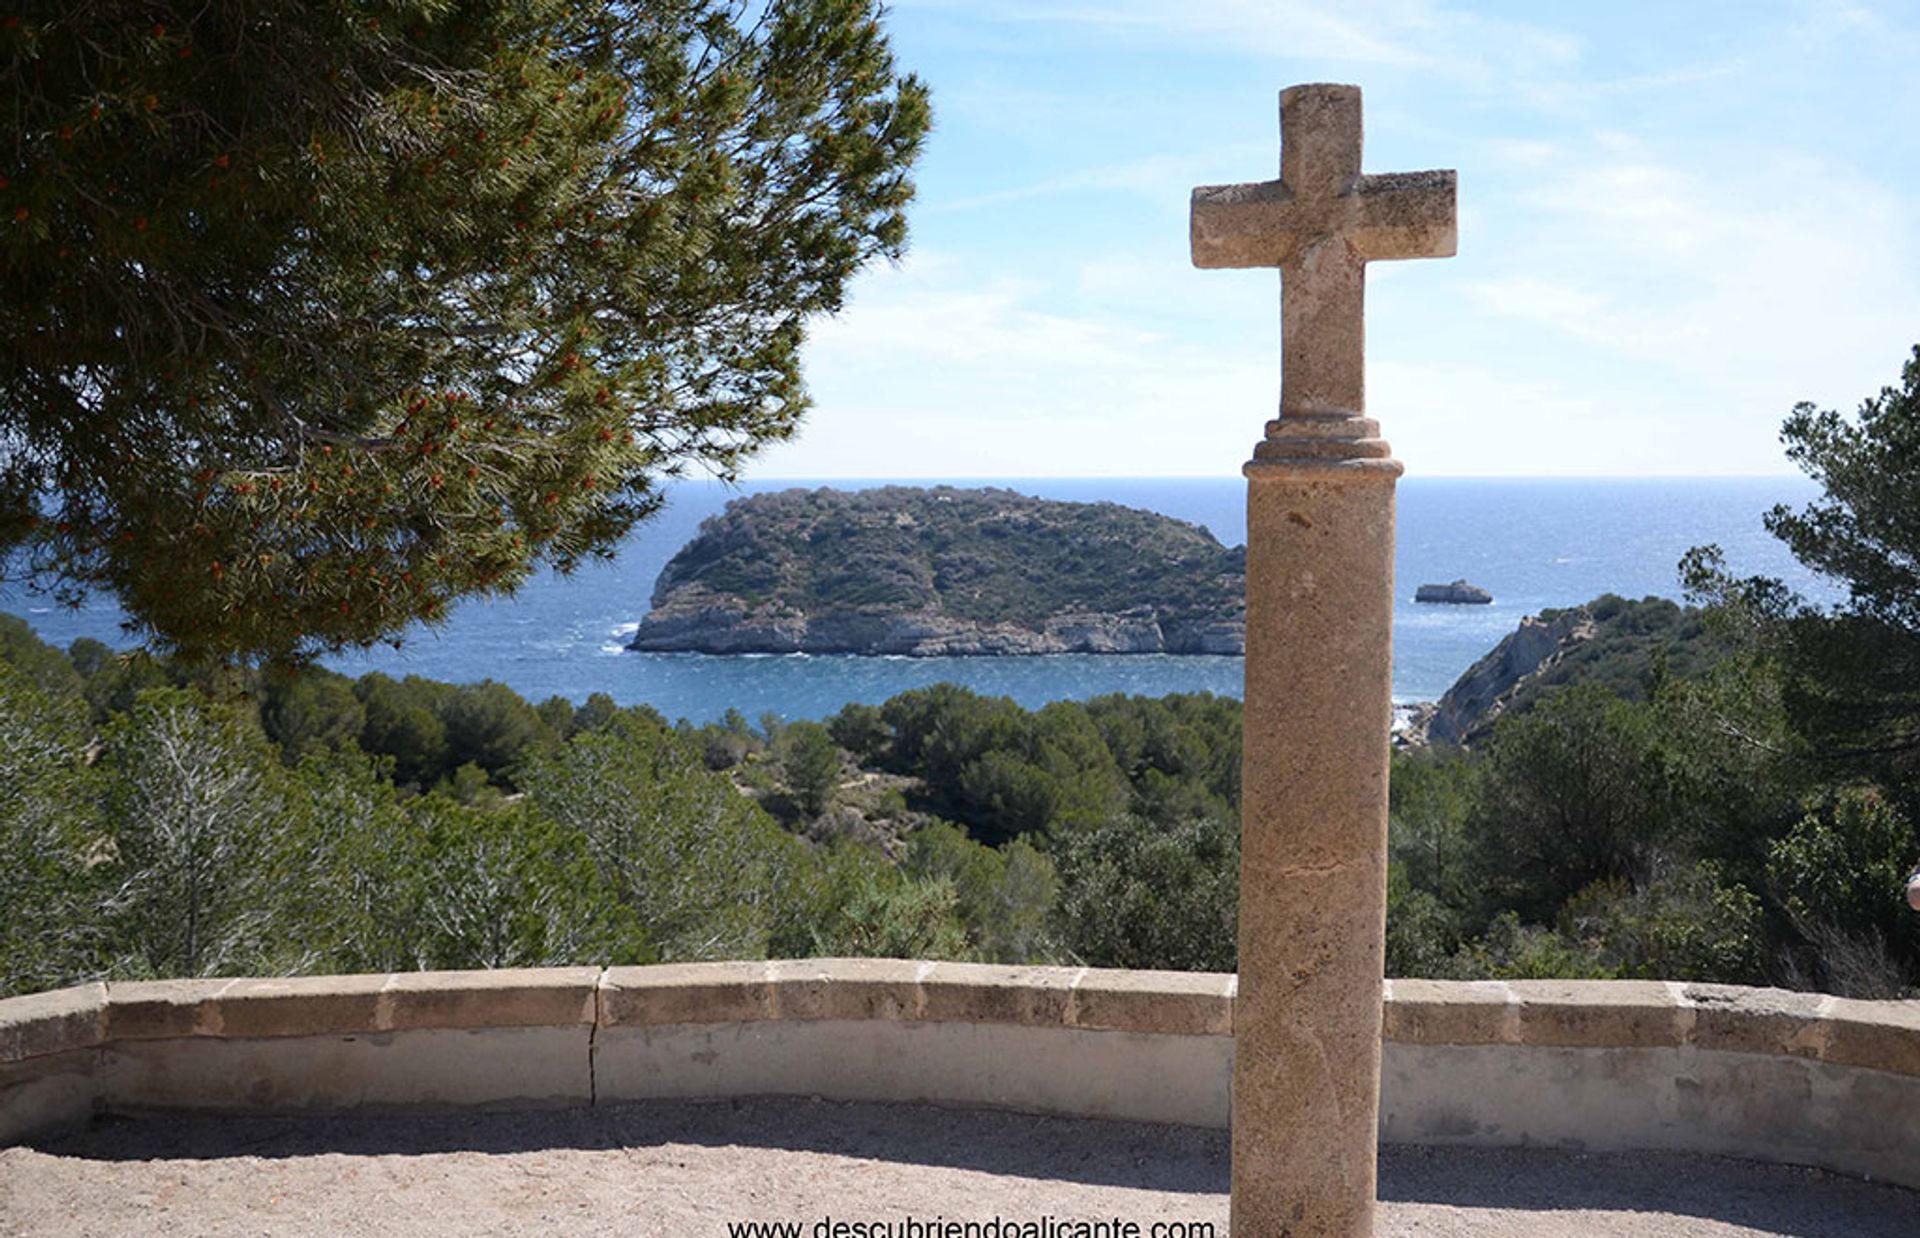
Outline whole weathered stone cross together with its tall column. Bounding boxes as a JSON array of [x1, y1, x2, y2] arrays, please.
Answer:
[[1192, 86, 1453, 1238]]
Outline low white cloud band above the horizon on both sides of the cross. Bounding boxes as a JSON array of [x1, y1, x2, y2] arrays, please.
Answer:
[[756, 216, 1866, 478]]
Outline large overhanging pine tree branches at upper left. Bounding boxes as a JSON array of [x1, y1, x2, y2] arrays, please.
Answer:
[[0, 0, 927, 660]]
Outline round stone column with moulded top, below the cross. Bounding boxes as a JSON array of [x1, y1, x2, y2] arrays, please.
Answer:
[[1233, 417, 1400, 1238]]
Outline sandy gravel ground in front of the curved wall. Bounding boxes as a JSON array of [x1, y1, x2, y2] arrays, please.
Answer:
[[0, 1100, 1920, 1238]]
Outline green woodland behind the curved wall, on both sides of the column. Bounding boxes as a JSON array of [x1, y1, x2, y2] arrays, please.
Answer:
[[0, 599, 1920, 996]]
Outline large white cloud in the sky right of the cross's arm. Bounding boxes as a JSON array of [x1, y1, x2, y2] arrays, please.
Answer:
[[1467, 142, 1920, 429]]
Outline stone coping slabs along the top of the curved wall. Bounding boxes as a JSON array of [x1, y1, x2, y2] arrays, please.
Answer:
[[0, 958, 1920, 1077]]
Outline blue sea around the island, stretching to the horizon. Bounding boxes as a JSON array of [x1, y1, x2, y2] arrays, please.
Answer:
[[0, 476, 1836, 724]]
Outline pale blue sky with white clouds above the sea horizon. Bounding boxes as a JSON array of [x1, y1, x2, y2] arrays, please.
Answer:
[[749, 0, 1920, 478]]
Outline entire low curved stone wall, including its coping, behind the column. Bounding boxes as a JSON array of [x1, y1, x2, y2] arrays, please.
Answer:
[[0, 960, 1920, 1188]]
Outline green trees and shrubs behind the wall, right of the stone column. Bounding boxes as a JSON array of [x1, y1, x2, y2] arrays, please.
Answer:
[[1388, 349, 1920, 996]]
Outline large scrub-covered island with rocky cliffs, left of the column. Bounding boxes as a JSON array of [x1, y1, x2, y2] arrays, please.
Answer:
[[630, 486, 1246, 656]]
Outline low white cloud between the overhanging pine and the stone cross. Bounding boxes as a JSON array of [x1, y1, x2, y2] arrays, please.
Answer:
[[758, 255, 1277, 476]]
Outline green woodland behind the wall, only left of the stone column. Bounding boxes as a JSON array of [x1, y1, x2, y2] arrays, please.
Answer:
[[0, 616, 1238, 992]]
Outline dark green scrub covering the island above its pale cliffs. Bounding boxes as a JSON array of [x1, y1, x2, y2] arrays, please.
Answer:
[[655, 486, 1246, 626]]
